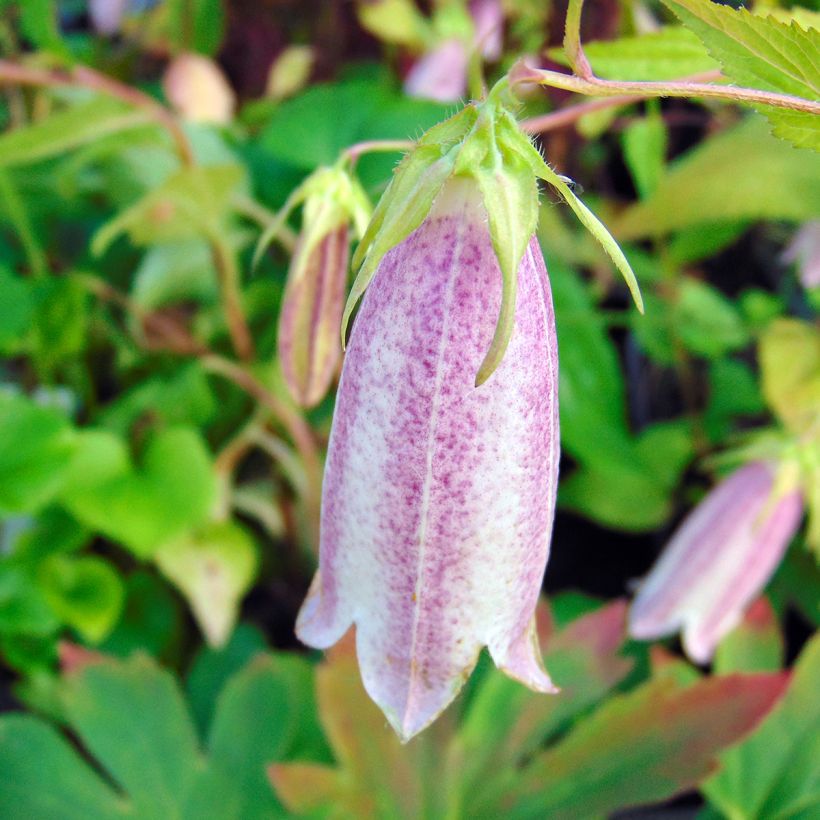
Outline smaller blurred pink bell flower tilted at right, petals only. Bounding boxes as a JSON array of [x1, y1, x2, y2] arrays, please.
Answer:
[[629, 461, 803, 663]]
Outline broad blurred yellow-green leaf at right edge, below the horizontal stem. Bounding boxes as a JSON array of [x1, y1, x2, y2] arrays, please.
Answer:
[[613, 117, 820, 240]]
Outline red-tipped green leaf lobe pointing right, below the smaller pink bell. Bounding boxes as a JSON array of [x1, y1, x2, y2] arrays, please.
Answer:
[[494, 673, 788, 820]]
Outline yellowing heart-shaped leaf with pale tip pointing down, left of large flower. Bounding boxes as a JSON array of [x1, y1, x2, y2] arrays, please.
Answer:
[[154, 521, 258, 646]]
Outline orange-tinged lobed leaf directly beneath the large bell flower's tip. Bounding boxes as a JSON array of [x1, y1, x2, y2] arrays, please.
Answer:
[[270, 601, 632, 818]]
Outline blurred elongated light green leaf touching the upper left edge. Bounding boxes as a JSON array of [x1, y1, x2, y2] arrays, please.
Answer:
[[0, 97, 150, 168]]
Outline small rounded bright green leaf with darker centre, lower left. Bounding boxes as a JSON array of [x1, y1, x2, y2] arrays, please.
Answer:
[[38, 555, 125, 643]]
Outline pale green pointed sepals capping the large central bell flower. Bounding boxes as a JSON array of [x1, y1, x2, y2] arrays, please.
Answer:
[[342, 80, 643, 386]]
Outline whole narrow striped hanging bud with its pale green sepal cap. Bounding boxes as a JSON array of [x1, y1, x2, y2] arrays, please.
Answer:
[[260, 167, 370, 407]]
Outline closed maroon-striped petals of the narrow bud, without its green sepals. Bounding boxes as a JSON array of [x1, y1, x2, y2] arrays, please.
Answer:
[[278, 223, 349, 407]]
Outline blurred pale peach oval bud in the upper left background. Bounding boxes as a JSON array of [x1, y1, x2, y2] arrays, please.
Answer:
[[162, 54, 236, 125]]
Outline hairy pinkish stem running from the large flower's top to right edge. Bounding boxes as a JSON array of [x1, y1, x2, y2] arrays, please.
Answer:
[[510, 64, 820, 114]]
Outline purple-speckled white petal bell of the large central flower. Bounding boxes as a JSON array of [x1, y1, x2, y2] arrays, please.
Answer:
[[297, 179, 559, 740]]
